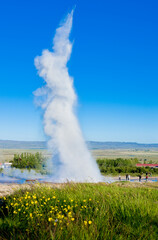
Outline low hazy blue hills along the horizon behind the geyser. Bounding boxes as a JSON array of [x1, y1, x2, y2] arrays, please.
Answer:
[[0, 140, 158, 150]]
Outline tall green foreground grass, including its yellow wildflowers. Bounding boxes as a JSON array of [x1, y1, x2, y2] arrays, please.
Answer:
[[0, 183, 158, 240]]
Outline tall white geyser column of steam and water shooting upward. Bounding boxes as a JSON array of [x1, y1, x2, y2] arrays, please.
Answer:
[[35, 11, 102, 182]]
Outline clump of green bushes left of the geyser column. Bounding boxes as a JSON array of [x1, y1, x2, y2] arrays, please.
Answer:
[[11, 152, 46, 170]]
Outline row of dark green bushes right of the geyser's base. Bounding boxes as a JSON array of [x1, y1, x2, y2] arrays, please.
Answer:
[[97, 158, 158, 175]]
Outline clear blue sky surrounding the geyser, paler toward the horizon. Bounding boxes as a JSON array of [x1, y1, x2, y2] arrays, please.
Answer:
[[0, 0, 158, 143]]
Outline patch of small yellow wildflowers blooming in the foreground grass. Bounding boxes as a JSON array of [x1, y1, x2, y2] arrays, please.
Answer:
[[4, 191, 92, 229]]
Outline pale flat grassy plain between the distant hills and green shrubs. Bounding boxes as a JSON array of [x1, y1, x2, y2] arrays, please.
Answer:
[[0, 149, 158, 163]]
